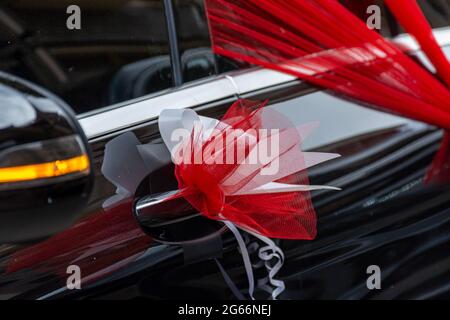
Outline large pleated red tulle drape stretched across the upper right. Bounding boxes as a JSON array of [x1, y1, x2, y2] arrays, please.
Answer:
[[206, 0, 450, 180]]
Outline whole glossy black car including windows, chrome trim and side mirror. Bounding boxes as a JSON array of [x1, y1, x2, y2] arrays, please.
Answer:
[[0, 0, 450, 299]]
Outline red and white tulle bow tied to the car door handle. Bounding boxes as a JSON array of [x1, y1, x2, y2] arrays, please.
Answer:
[[159, 100, 339, 239]]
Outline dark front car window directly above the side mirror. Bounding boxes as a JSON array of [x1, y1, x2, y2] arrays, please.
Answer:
[[0, 0, 172, 113]]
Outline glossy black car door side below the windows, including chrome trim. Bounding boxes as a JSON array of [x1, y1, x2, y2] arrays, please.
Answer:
[[0, 1, 448, 299]]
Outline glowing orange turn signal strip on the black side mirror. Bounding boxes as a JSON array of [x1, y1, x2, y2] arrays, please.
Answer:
[[0, 154, 89, 183]]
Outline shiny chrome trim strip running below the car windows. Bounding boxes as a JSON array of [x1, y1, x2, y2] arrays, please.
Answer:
[[79, 27, 450, 140]]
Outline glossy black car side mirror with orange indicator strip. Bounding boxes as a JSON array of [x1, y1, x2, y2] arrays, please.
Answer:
[[0, 72, 93, 244]]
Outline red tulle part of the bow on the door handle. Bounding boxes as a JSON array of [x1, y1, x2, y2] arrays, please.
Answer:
[[171, 100, 316, 239]]
